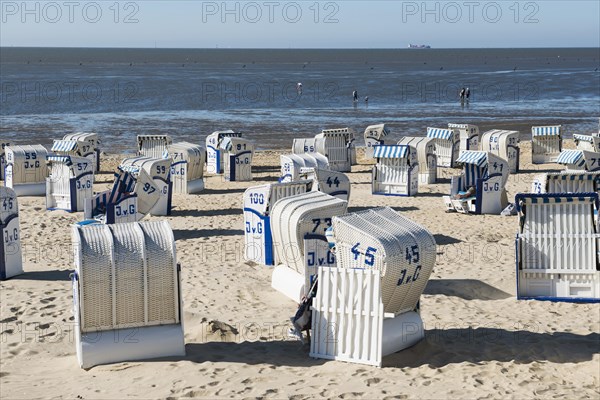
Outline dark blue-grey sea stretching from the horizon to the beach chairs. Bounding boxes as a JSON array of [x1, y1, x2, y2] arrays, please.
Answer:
[[0, 48, 600, 152]]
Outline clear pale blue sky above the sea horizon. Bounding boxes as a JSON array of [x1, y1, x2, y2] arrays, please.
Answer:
[[0, 0, 600, 48]]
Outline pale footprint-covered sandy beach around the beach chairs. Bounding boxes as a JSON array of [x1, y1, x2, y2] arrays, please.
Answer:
[[0, 142, 600, 399]]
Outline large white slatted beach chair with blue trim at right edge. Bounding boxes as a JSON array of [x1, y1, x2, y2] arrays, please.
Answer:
[[515, 193, 600, 302]]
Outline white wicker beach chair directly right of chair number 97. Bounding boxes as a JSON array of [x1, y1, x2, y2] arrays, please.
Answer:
[[167, 142, 206, 194]]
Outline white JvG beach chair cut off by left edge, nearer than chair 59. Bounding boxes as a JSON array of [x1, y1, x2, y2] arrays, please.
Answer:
[[0, 186, 23, 281]]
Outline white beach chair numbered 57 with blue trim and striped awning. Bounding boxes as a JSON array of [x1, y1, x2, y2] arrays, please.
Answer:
[[46, 155, 94, 212]]
